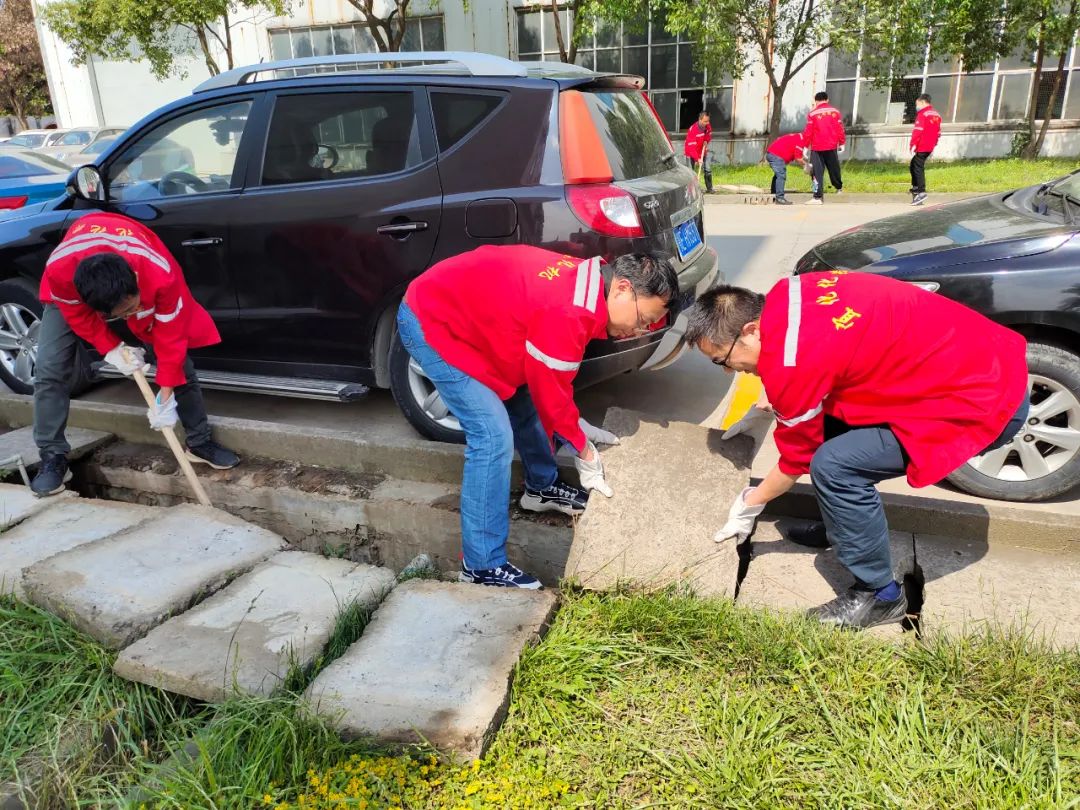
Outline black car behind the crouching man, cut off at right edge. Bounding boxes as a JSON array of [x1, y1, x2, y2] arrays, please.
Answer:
[[796, 171, 1080, 501]]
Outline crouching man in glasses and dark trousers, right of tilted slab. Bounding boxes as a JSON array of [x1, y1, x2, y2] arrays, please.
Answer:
[[687, 271, 1028, 627]]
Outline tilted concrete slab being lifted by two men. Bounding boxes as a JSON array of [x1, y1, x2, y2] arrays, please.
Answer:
[[566, 408, 754, 596]]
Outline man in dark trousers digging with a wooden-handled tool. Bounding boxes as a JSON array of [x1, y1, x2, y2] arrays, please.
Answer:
[[30, 214, 240, 497]]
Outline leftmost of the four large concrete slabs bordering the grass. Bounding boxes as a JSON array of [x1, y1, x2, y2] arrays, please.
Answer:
[[0, 501, 158, 596]]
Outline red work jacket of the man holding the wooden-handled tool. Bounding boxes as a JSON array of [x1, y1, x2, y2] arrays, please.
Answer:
[[39, 214, 221, 388]]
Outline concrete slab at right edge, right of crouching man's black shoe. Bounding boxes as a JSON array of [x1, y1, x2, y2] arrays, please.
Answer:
[[917, 535, 1080, 647]]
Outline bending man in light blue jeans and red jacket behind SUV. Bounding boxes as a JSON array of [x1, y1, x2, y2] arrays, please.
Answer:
[[397, 245, 678, 590]]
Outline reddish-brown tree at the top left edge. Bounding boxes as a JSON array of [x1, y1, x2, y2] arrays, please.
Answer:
[[0, 0, 52, 129]]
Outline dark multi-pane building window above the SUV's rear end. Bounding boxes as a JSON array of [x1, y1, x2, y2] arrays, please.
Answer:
[[517, 9, 733, 133]]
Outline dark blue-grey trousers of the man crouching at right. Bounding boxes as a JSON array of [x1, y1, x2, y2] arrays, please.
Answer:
[[810, 397, 1030, 591]]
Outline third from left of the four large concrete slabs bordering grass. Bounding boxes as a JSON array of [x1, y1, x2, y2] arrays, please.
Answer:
[[113, 551, 394, 702]]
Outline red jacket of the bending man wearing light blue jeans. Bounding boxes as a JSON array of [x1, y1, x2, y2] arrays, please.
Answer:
[[405, 245, 608, 451]]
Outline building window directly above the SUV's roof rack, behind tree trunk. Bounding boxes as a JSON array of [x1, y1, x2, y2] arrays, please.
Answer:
[[269, 15, 445, 59]]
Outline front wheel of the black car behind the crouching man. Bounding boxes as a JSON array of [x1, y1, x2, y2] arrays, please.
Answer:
[[947, 342, 1080, 501]]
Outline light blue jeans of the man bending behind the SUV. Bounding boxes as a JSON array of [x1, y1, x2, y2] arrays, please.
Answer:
[[397, 302, 558, 569]]
